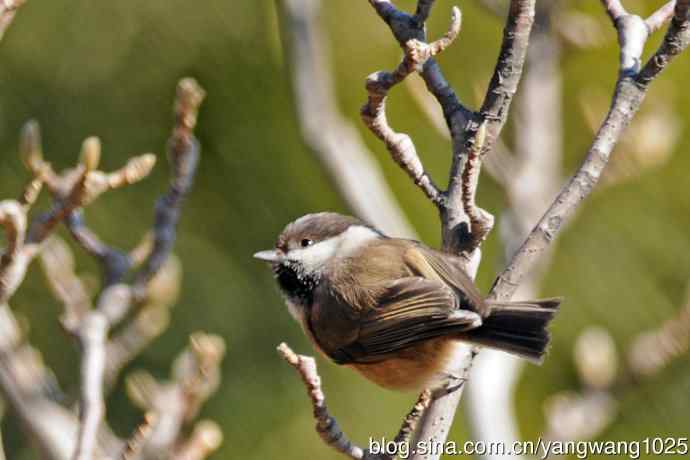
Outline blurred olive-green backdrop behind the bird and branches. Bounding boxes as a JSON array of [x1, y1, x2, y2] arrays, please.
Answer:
[[0, 0, 690, 460]]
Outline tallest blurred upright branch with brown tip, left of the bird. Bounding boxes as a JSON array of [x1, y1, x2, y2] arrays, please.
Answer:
[[70, 79, 204, 460]]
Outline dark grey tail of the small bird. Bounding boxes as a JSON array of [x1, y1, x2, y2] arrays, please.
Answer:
[[465, 298, 562, 364]]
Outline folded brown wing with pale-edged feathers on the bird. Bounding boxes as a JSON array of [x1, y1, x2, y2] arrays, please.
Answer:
[[329, 276, 481, 364]]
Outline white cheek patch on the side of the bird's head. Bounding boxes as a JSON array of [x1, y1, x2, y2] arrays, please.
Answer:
[[288, 225, 380, 271]]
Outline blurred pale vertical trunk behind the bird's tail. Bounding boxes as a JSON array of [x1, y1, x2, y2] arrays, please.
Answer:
[[463, 2, 563, 460]]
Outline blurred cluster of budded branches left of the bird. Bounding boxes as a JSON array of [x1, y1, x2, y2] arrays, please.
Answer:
[[0, 9, 224, 452]]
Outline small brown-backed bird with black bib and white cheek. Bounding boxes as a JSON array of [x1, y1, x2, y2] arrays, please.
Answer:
[[254, 212, 561, 390]]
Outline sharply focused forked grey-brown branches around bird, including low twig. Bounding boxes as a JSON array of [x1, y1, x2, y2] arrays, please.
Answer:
[[279, 0, 690, 460]]
